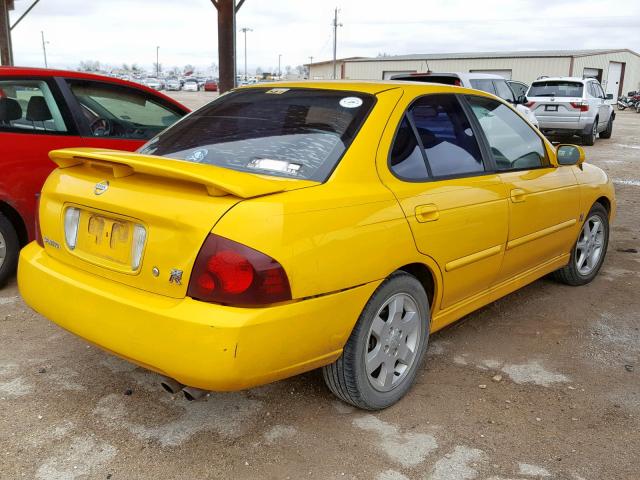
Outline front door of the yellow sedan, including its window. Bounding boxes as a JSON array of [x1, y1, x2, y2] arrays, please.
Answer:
[[467, 96, 580, 283]]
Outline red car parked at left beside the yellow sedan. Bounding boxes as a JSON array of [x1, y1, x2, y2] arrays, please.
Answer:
[[0, 67, 189, 285]]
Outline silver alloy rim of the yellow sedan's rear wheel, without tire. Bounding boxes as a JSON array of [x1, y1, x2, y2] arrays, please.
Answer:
[[365, 293, 422, 392]]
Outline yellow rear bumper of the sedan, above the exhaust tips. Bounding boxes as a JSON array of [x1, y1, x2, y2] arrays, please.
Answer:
[[18, 242, 380, 391]]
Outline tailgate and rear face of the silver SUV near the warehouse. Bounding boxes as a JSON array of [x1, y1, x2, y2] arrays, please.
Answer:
[[527, 80, 584, 130]]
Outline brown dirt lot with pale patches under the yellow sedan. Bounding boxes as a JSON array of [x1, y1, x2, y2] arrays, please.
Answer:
[[0, 99, 640, 480]]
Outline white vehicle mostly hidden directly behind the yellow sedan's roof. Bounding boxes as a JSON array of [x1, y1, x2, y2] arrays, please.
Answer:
[[391, 72, 538, 127]]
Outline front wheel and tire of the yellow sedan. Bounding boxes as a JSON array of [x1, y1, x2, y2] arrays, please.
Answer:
[[554, 203, 609, 286]]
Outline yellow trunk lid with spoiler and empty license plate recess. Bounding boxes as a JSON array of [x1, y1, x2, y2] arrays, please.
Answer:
[[39, 149, 317, 298]]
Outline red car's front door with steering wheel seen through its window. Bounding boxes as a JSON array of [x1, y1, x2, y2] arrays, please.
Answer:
[[63, 79, 185, 151]]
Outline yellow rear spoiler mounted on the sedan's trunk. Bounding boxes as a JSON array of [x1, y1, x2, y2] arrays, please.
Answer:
[[49, 148, 317, 198]]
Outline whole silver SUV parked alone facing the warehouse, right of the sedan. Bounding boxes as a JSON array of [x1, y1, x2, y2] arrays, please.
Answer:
[[527, 77, 616, 145]]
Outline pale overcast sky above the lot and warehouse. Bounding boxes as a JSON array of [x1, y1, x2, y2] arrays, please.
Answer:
[[11, 0, 640, 72]]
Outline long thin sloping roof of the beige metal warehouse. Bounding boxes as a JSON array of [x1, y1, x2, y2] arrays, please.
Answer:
[[345, 48, 640, 62]]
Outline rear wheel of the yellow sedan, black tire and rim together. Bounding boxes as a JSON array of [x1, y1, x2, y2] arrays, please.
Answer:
[[322, 272, 431, 410]]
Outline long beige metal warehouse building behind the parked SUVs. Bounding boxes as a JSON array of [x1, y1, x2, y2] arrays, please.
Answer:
[[309, 49, 640, 98]]
